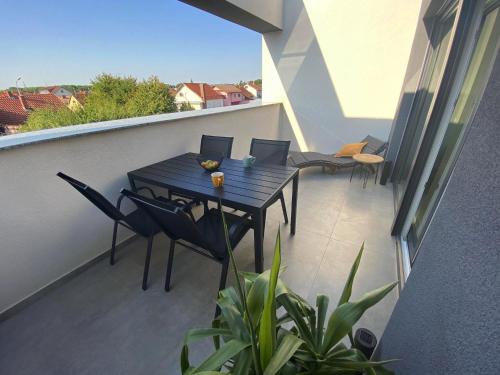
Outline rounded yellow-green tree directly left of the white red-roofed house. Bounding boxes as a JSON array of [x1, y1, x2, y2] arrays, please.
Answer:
[[126, 76, 177, 116]]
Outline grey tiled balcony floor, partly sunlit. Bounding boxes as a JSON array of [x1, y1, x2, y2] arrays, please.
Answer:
[[0, 169, 397, 375]]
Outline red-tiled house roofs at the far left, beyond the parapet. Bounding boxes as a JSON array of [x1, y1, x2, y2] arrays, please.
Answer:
[[0, 91, 64, 134]]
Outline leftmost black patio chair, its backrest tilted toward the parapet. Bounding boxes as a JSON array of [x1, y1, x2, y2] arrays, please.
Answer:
[[57, 172, 194, 290]]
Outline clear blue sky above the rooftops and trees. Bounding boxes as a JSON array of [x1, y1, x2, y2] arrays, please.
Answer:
[[0, 0, 261, 88]]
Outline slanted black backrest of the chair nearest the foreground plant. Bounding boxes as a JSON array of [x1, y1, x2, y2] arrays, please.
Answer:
[[121, 189, 214, 255]]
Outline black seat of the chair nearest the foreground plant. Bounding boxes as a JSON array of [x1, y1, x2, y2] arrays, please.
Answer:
[[196, 208, 251, 259]]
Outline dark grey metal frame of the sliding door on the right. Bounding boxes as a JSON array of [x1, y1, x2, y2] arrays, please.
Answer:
[[392, 0, 500, 283]]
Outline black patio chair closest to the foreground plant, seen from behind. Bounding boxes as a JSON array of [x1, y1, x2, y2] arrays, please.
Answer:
[[121, 189, 251, 314]]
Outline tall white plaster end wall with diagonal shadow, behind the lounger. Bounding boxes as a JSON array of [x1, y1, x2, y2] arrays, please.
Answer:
[[262, 0, 421, 153]]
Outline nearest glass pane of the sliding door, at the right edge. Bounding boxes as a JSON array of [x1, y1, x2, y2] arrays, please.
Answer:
[[405, 5, 500, 264]]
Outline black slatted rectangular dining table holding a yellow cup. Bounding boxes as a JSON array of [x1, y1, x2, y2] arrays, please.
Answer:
[[128, 153, 299, 273]]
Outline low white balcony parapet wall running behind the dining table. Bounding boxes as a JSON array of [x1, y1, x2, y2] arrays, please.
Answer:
[[0, 104, 279, 312]]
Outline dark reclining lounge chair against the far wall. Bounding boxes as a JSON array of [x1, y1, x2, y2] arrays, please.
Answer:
[[287, 135, 387, 171]]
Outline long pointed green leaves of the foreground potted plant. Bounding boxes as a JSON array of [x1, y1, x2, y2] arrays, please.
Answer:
[[181, 210, 396, 375]]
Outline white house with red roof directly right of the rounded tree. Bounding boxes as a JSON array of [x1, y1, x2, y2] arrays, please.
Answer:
[[175, 83, 224, 109]]
